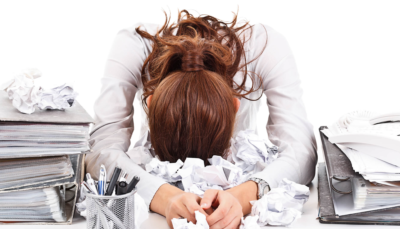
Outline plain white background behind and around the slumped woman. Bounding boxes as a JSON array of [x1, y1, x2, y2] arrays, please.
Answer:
[[0, 0, 400, 159]]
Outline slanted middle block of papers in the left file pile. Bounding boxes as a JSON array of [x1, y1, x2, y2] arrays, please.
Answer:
[[0, 156, 74, 191]]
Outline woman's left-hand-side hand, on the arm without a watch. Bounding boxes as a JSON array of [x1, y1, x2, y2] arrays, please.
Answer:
[[150, 184, 207, 228]]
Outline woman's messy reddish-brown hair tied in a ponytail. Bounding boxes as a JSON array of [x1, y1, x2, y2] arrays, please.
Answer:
[[136, 10, 261, 163]]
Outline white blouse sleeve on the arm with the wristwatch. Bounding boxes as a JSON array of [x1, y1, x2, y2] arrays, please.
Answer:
[[251, 25, 317, 188]]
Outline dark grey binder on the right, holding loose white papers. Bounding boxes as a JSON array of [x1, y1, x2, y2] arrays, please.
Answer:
[[318, 126, 400, 225]]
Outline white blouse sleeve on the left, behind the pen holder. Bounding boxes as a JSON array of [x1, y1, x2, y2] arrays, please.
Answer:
[[85, 25, 165, 209]]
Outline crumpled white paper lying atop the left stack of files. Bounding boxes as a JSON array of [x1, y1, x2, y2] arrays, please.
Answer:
[[0, 68, 78, 114]]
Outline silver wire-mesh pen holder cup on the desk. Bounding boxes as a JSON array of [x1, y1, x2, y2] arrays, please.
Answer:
[[86, 189, 136, 229]]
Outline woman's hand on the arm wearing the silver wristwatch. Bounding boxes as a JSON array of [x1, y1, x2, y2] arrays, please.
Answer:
[[200, 189, 243, 229]]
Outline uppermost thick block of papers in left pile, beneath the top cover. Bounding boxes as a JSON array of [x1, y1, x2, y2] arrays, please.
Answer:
[[0, 122, 89, 158]]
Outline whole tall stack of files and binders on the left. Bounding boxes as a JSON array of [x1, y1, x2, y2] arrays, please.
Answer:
[[0, 92, 93, 224]]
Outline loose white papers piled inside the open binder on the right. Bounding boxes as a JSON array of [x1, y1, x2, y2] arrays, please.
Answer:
[[321, 111, 400, 212]]
